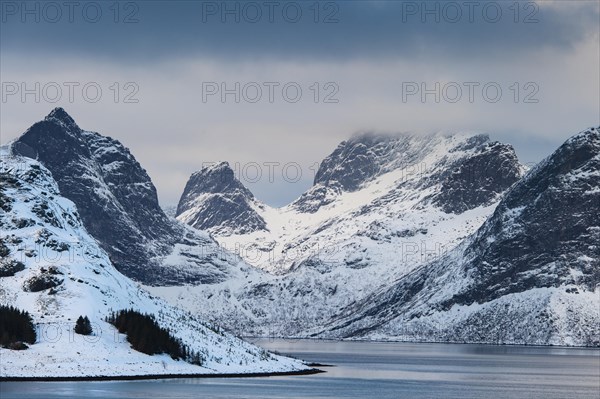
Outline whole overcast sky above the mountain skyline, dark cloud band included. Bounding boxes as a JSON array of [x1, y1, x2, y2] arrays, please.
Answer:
[[0, 0, 600, 206]]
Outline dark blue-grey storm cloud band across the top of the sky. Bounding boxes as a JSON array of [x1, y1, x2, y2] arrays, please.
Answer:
[[1, 1, 598, 62]]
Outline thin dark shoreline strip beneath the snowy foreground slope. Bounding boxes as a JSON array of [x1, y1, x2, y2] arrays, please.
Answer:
[[0, 368, 326, 382]]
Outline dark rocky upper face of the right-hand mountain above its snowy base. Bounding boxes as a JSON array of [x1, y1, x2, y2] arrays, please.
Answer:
[[450, 128, 600, 303]]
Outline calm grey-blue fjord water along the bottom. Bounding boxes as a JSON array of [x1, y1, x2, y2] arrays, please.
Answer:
[[0, 339, 600, 399]]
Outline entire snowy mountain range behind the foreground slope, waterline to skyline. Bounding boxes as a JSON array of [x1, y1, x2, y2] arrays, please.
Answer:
[[8, 109, 600, 345]]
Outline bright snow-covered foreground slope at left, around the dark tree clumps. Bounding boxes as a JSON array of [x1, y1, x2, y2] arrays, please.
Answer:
[[0, 152, 308, 378]]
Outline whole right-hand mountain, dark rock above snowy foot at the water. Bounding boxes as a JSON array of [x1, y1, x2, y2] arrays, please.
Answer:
[[320, 128, 600, 346]]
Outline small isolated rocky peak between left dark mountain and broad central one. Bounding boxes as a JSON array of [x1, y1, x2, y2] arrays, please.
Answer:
[[176, 162, 266, 235]]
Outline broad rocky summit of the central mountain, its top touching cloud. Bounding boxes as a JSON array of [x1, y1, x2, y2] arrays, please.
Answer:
[[292, 133, 523, 213]]
